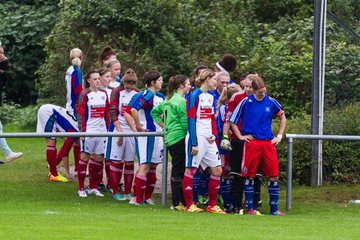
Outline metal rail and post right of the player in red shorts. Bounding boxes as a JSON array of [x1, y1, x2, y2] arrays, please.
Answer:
[[286, 134, 360, 211]]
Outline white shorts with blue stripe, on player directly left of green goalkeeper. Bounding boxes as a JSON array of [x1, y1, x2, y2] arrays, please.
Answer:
[[135, 137, 164, 164]]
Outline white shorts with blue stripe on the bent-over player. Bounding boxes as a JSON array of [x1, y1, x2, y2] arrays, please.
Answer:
[[36, 104, 79, 139]]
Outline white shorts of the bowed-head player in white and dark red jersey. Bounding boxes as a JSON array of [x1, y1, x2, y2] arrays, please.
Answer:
[[105, 129, 135, 162]]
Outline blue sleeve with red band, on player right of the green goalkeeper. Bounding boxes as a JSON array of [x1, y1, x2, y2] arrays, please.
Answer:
[[186, 92, 199, 147]]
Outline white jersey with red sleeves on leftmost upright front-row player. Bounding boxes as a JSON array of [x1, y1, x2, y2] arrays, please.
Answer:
[[78, 89, 109, 132]]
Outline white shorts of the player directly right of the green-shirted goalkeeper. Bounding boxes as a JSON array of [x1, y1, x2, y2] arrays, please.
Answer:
[[185, 134, 221, 170]]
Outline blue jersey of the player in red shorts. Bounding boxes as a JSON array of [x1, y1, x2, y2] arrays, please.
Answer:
[[229, 95, 284, 140]]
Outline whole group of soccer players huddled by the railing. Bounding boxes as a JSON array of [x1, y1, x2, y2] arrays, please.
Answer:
[[37, 47, 286, 216]]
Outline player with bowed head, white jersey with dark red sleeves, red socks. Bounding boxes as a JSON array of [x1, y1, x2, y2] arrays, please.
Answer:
[[105, 68, 139, 201]]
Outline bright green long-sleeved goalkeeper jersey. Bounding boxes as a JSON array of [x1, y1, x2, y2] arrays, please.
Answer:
[[151, 92, 187, 147]]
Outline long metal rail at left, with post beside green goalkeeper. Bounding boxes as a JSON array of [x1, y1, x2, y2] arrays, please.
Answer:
[[0, 132, 168, 207]]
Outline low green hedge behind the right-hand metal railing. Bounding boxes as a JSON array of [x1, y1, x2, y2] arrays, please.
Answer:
[[280, 103, 360, 184]]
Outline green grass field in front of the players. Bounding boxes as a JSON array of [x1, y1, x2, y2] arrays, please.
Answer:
[[0, 124, 360, 240]]
